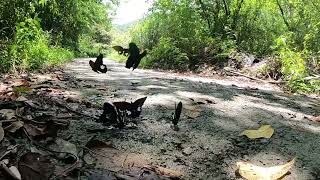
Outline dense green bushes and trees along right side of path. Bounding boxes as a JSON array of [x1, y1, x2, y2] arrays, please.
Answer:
[[124, 0, 320, 92]]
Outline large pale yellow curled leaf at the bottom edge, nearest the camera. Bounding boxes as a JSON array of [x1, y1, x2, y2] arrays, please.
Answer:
[[237, 158, 295, 180]]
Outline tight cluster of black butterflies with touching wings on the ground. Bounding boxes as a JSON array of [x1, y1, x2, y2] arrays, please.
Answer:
[[99, 97, 147, 128]]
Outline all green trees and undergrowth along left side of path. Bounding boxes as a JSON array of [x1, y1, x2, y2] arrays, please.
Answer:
[[0, 0, 112, 73]]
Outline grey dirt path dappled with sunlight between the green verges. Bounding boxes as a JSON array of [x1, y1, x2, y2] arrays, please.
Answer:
[[65, 59, 320, 180]]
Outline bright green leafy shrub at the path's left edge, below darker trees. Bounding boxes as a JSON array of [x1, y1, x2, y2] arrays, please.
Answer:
[[0, 18, 74, 72]]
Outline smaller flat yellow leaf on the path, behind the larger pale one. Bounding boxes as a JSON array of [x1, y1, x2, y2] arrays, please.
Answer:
[[240, 125, 274, 139]]
